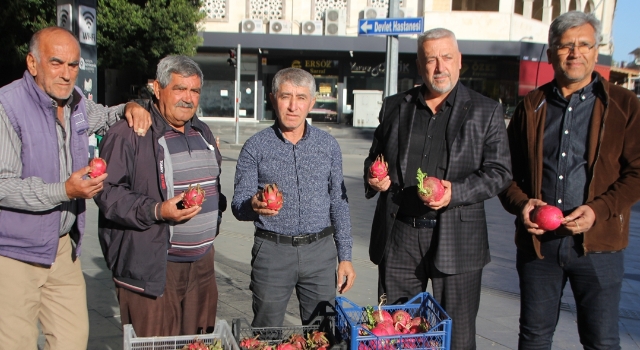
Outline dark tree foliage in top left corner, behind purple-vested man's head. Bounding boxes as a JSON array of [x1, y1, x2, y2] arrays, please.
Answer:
[[0, 0, 56, 86]]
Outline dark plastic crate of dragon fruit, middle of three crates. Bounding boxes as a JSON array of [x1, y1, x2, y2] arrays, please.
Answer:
[[232, 317, 347, 350]]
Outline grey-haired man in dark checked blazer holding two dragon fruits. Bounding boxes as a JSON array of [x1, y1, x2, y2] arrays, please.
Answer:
[[364, 28, 511, 350]]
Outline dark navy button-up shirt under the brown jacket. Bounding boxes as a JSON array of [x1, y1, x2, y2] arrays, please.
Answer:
[[542, 76, 597, 215]]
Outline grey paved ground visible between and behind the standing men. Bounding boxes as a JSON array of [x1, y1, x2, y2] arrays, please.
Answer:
[[72, 122, 640, 350]]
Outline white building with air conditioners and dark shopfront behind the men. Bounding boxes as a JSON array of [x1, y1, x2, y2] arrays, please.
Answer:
[[195, 0, 615, 122]]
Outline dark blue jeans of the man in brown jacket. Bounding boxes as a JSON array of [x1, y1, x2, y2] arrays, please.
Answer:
[[516, 233, 624, 350]]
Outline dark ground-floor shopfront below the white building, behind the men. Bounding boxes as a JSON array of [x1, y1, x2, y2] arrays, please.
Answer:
[[196, 32, 611, 123]]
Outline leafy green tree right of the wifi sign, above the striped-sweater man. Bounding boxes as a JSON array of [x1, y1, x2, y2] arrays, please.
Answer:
[[97, 0, 205, 77]]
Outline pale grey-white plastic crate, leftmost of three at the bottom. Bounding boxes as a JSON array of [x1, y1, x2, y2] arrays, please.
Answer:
[[123, 320, 240, 350]]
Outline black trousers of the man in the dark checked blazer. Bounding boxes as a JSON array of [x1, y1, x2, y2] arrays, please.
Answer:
[[378, 221, 482, 350]]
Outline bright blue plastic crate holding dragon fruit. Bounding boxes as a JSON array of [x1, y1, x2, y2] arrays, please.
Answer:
[[336, 292, 451, 350]]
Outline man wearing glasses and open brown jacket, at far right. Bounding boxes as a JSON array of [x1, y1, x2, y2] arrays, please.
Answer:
[[500, 11, 640, 349]]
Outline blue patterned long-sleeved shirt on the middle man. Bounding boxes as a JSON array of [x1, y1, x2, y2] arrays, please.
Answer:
[[231, 123, 353, 261]]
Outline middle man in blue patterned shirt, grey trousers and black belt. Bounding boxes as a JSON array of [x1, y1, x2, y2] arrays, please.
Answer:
[[231, 68, 356, 327]]
